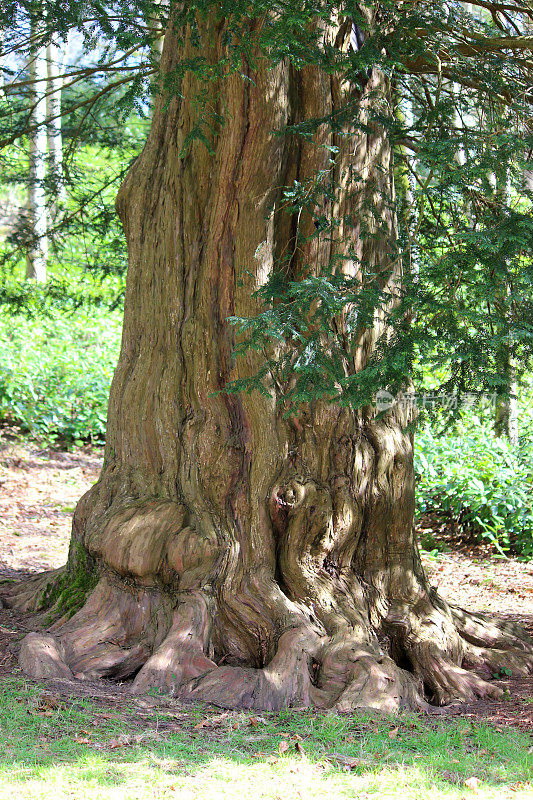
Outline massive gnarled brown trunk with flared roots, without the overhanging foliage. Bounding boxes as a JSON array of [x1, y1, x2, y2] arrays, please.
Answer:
[[8, 7, 533, 710]]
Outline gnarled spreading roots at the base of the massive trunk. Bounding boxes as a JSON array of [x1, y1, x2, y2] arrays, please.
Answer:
[[4, 575, 533, 713]]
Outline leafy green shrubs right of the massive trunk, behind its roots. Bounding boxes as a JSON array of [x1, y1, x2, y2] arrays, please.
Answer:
[[415, 417, 533, 558]]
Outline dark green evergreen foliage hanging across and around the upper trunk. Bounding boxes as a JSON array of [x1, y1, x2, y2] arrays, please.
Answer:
[[0, 0, 533, 410]]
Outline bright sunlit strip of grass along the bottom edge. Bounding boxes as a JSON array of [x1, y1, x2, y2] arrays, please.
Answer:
[[0, 746, 530, 800]]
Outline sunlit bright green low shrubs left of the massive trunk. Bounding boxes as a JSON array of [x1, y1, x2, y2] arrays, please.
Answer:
[[0, 309, 121, 444]]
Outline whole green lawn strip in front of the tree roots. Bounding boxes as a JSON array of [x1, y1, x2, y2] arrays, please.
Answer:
[[0, 677, 533, 800]]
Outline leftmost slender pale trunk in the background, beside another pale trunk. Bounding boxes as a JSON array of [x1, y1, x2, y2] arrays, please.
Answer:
[[26, 25, 48, 283]]
